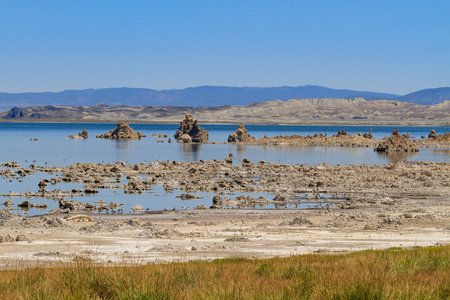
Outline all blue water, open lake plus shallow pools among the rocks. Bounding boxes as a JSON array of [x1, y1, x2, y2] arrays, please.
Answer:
[[0, 123, 450, 214]]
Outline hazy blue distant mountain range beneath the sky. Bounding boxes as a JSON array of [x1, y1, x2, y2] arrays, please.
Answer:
[[0, 85, 450, 110]]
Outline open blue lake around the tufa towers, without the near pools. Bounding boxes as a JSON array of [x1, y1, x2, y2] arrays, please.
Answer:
[[0, 123, 450, 165]]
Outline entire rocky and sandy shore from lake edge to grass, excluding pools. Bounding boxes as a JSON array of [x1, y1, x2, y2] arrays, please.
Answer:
[[0, 159, 450, 268]]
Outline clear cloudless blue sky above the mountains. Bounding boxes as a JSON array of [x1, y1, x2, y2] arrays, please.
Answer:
[[0, 0, 450, 94]]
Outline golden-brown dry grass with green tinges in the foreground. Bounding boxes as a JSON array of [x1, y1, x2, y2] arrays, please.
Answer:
[[0, 246, 450, 299]]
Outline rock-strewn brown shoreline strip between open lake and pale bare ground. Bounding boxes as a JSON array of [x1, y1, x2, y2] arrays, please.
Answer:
[[0, 158, 450, 209]]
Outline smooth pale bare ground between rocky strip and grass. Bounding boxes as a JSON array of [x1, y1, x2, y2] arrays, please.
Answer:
[[0, 197, 450, 269]]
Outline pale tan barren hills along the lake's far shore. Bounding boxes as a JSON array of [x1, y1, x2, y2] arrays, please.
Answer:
[[0, 98, 450, 125]]
